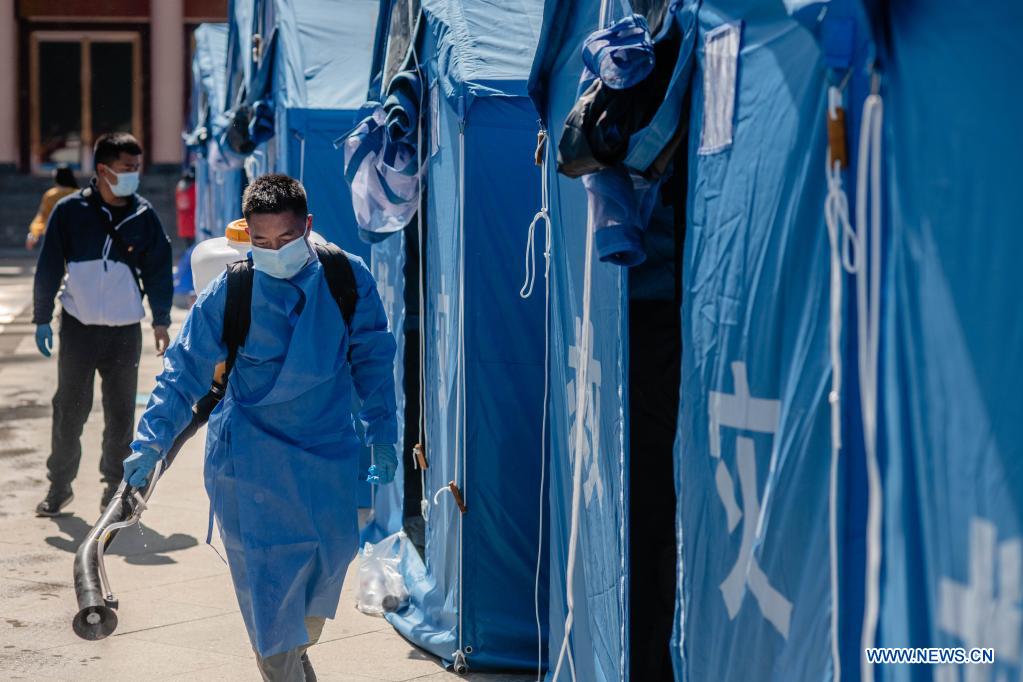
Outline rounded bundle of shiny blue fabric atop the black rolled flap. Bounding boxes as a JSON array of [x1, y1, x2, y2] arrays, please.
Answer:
[[582, 14, 654, 90]]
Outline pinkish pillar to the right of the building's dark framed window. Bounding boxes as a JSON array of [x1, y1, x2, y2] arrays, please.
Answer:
[[149, 0, 185, 164]]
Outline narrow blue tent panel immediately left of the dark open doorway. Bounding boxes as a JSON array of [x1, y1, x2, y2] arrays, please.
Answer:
[[530, 0, 629, 682]]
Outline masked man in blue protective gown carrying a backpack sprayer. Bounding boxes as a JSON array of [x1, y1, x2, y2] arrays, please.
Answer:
[[125, 175, 397, 681]]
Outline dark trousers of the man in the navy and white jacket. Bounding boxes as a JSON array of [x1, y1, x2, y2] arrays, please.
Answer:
[[46, 313, 142, 487]]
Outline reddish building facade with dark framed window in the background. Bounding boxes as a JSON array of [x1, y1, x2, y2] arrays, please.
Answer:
[[0, 0, 227, 175]]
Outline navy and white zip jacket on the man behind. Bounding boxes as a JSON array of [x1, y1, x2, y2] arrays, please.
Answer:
[[32, 180, 174, 326]]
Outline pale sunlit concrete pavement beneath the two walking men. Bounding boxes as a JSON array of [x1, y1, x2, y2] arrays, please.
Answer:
[[0, 260, 535, 682]]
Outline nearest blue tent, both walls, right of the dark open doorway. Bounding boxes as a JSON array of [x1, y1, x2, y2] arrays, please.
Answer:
[[676, 0, 1023, 680]]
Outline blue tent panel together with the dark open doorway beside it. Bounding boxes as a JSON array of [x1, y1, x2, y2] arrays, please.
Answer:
[[530, 0, 684, 682]]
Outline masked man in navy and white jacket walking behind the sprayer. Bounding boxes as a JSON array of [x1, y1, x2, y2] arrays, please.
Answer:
[[32, 133, 174, 516]]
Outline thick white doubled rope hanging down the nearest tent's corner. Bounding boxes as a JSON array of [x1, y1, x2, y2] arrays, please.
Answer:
[[856, 73, 884, 682]]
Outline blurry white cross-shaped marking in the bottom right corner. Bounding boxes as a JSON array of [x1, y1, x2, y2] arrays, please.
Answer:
[[938, 516, 1023, 682]]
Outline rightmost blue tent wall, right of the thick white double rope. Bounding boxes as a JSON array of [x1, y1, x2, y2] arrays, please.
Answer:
[[864, 0, 1023, 681]]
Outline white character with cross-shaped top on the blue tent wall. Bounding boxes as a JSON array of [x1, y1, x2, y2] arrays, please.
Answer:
[[708, 362, 792, 639]]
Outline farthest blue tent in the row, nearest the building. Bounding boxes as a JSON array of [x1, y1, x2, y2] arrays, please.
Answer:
[[189, 24, 241, 240]]
